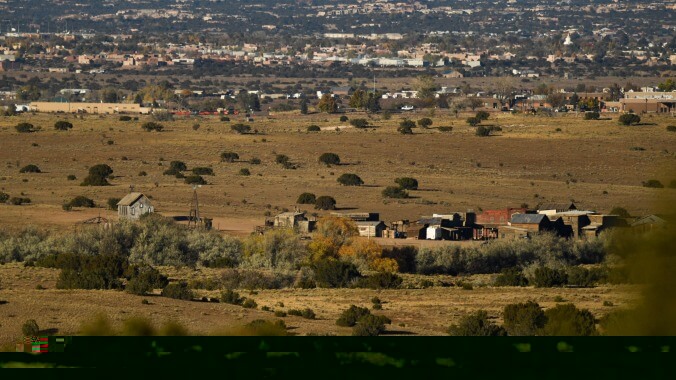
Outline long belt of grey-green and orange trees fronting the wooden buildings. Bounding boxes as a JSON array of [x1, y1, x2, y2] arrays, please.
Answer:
[[0, 212, 656, 296]]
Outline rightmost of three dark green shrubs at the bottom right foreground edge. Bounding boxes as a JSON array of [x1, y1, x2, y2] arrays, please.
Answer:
[[542, 304, 596, 336]]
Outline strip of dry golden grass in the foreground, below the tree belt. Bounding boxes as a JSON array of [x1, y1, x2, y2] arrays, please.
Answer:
[[0, 263, 639, 351]]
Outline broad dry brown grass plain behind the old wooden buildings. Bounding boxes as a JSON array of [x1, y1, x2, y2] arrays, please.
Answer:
[[0, 111, 676, 235]]
